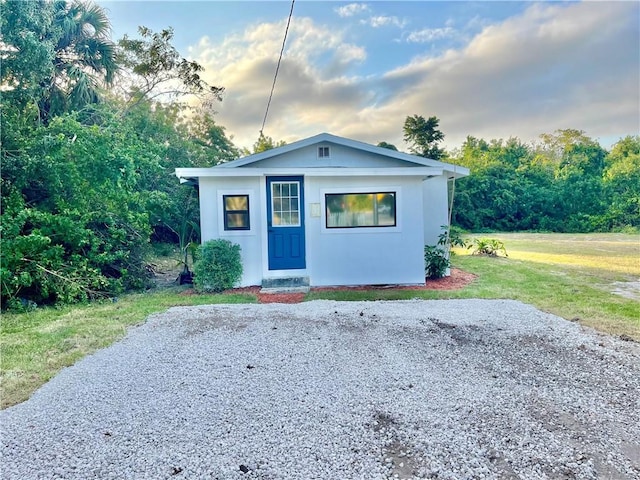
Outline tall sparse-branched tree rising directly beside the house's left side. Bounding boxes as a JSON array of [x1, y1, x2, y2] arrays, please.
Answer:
[[113, 26, 232, 246]]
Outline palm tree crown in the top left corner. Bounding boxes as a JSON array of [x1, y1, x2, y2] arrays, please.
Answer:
[[1, 0, 117, 123]]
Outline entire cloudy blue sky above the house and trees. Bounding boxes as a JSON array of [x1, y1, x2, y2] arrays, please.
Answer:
[[99, 0, 640, 150]]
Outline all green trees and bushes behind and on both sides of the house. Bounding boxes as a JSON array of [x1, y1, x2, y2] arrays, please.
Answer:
[[0, 0, 640, 309]]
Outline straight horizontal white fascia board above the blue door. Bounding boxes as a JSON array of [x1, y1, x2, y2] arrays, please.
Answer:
[[176, 167, 444, 179]]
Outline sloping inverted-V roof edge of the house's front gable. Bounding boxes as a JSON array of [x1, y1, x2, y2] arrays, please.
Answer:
[[213, 133, 469, 176]]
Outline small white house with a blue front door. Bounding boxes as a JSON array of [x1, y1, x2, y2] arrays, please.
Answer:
[[176, 133, 469, 286]]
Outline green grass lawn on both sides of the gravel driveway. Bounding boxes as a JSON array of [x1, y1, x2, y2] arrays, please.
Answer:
[[0, 233, 640, 408]]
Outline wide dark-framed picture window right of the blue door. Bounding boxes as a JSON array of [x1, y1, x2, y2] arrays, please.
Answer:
[[325, 192, 396, 228]]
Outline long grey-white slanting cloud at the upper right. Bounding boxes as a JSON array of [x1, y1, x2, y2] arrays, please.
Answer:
[[372, 3, 640, 146]]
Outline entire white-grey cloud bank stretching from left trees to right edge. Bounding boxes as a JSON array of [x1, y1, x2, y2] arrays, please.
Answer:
[[191, 2, 640, 152]]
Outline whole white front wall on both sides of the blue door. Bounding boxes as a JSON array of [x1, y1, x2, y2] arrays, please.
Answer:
[[200, 172, 425, 286]]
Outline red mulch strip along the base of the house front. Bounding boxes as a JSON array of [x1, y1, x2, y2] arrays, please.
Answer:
[[198, 268, 477, 303]]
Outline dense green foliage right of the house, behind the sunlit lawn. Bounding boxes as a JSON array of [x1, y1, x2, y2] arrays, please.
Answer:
[[451, 130, 640, 232]]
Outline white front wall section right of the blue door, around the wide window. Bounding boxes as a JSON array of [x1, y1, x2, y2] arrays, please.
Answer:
[[306, 177, 424, 286]]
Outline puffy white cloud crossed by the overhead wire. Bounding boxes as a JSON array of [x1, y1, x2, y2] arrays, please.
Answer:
[[190, 18, 372, 147]]
